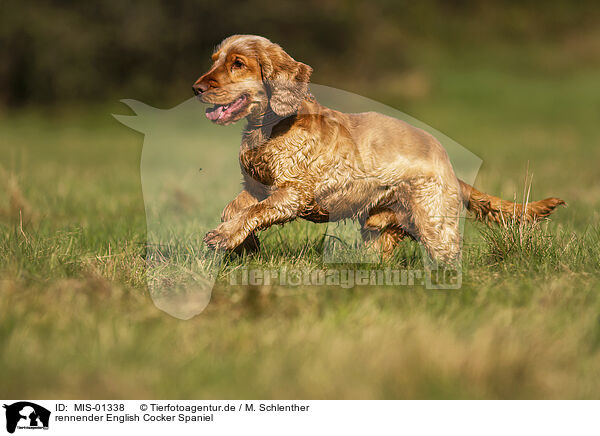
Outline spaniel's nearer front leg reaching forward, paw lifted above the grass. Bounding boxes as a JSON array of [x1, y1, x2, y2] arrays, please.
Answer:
[[204, 187, 303, 250]]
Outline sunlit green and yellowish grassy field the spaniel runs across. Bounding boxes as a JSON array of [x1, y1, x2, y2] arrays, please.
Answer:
[[0, 48, 600, 398]]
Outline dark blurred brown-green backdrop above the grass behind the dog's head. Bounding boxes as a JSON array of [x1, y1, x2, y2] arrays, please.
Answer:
[[0, 0, 600, 107]]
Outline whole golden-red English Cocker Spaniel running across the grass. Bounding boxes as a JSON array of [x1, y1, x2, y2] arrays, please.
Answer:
[[193, 35, 564, 263]]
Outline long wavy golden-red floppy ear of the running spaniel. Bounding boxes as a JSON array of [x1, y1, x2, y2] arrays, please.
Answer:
[[259, 43, 312, 117]]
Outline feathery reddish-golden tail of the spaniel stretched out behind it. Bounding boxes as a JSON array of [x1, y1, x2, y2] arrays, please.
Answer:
[[459, 180, 566, 225]]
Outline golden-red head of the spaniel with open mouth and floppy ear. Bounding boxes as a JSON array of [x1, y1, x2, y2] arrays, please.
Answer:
[[192, 35, 312, 125]]
